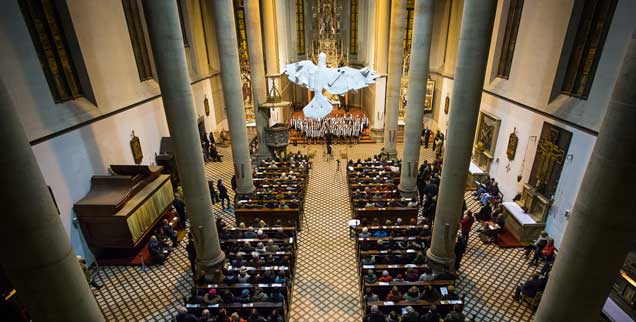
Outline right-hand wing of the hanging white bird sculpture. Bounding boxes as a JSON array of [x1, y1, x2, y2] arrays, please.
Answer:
[[326, 66, 378, 95]]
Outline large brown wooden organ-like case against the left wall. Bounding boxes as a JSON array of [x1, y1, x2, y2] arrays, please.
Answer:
[[73, 165, 174, 254]]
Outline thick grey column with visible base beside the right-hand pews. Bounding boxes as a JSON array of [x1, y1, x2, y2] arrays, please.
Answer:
[[427, 0, 497, 265]]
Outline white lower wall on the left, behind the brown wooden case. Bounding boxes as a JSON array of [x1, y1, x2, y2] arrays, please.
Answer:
[[33, 81, 216, 261]]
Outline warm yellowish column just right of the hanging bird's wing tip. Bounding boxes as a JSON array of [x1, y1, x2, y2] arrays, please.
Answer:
[[384, 0, 406, 159]]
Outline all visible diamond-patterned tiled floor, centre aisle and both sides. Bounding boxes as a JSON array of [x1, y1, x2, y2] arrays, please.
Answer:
[[95, 144, 534, 322]]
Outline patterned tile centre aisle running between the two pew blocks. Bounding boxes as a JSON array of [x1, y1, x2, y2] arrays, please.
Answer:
[[290, 146, 362, 322]]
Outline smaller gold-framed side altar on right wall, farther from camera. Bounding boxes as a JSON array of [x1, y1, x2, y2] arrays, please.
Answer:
[[473, 111, 501, 172]]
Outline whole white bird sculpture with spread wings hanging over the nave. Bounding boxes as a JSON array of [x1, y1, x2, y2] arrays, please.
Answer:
[[285, 53, 378, 119]]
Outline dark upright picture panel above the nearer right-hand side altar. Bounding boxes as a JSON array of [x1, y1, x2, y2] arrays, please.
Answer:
[[528, 122, 572, 198]]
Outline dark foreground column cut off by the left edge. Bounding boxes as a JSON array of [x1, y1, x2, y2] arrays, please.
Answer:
[[0, 84, 104, 322]]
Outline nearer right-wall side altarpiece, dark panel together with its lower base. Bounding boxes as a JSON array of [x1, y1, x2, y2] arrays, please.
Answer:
[[520, 122, 572, 222]]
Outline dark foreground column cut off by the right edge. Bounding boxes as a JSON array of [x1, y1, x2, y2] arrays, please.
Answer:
[[534, 33, 636, 322]]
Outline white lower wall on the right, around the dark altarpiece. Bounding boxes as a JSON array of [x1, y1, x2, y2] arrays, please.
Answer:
[[435, 78, 596, 246]]
